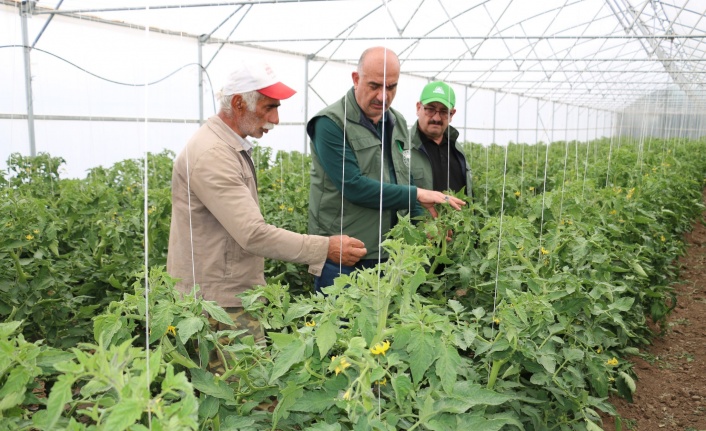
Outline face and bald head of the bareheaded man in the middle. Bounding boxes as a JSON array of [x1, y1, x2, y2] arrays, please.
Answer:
[[353, 53, 400, 123]]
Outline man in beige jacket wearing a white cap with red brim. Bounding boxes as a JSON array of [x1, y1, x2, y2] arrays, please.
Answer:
[[167, 62, 366, 340]]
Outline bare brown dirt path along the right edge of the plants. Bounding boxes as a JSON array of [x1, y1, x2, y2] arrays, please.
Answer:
[[603, 193, 706, 431]]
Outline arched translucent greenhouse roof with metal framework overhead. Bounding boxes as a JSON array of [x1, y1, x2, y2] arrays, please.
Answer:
[[9, 0, 706, 110]]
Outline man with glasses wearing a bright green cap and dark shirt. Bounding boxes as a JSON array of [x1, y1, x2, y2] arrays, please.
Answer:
[[410, 81, 471, 195]]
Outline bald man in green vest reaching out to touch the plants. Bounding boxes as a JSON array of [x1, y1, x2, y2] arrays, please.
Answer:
[[307, 47, 465, 290]]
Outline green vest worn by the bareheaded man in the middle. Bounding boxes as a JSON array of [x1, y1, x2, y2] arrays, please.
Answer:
[[307, 89, 414, 259]]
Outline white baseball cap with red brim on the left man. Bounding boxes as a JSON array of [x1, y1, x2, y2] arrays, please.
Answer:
[[223, 61, 296, 100]]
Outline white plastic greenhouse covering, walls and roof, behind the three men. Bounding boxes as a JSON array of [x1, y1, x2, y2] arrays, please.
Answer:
[[0, 0, 706, 177]]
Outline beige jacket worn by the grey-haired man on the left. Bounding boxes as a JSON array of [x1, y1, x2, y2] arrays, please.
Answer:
[[167, 116, 329, 307]]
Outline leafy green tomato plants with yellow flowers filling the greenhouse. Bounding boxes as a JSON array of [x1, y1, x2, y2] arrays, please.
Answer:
[[0, 141, 706, 430]]
